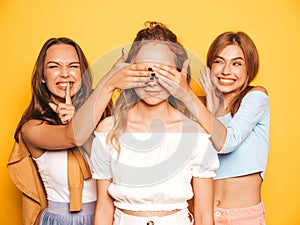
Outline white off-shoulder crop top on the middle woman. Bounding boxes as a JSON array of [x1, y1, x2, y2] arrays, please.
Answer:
[[90, 133, 219, 211]]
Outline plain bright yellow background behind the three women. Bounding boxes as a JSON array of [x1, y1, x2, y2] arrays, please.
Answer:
[[0, 0, 300, 225]]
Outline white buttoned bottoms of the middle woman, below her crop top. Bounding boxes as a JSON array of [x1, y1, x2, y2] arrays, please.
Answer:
[[113, 208, 193, 225]]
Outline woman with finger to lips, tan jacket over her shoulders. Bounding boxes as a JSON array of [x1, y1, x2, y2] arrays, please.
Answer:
[[8, 38, 154, 225]]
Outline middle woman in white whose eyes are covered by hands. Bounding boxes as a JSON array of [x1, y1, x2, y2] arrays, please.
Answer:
[[91, 22, 218, 225]]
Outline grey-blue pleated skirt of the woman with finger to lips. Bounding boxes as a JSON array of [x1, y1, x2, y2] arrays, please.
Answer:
[[39, 201, 96, 225]]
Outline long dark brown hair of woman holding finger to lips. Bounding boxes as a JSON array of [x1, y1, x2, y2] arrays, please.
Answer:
[[14, 37, 92, 141]]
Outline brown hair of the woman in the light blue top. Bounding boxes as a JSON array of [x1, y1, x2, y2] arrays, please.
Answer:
[[206, 31, 259, 115]]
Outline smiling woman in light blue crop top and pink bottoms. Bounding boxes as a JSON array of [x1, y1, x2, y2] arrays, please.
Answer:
[[155, 32, 270, 225]]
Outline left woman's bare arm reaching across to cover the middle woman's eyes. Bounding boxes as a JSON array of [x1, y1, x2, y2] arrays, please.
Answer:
[[21, 53, 150, 154]]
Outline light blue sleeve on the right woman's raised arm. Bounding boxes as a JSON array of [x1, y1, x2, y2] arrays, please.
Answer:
[[219, 91, 270, 154]]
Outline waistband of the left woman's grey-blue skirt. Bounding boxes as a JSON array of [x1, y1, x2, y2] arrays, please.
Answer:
[[46, 201, 96, 215]]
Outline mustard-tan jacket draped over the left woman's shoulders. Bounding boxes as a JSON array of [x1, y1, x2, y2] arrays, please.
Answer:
[[7, 135, 91, 225]]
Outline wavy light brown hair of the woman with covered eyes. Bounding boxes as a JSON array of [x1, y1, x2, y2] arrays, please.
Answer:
[[107, 21, 191, 151]]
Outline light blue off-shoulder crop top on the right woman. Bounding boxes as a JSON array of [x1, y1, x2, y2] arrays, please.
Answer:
[[214, 91, 270, 180]]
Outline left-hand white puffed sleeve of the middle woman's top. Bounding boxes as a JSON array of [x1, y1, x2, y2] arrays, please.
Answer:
[[90, 133, 112, 180]]
